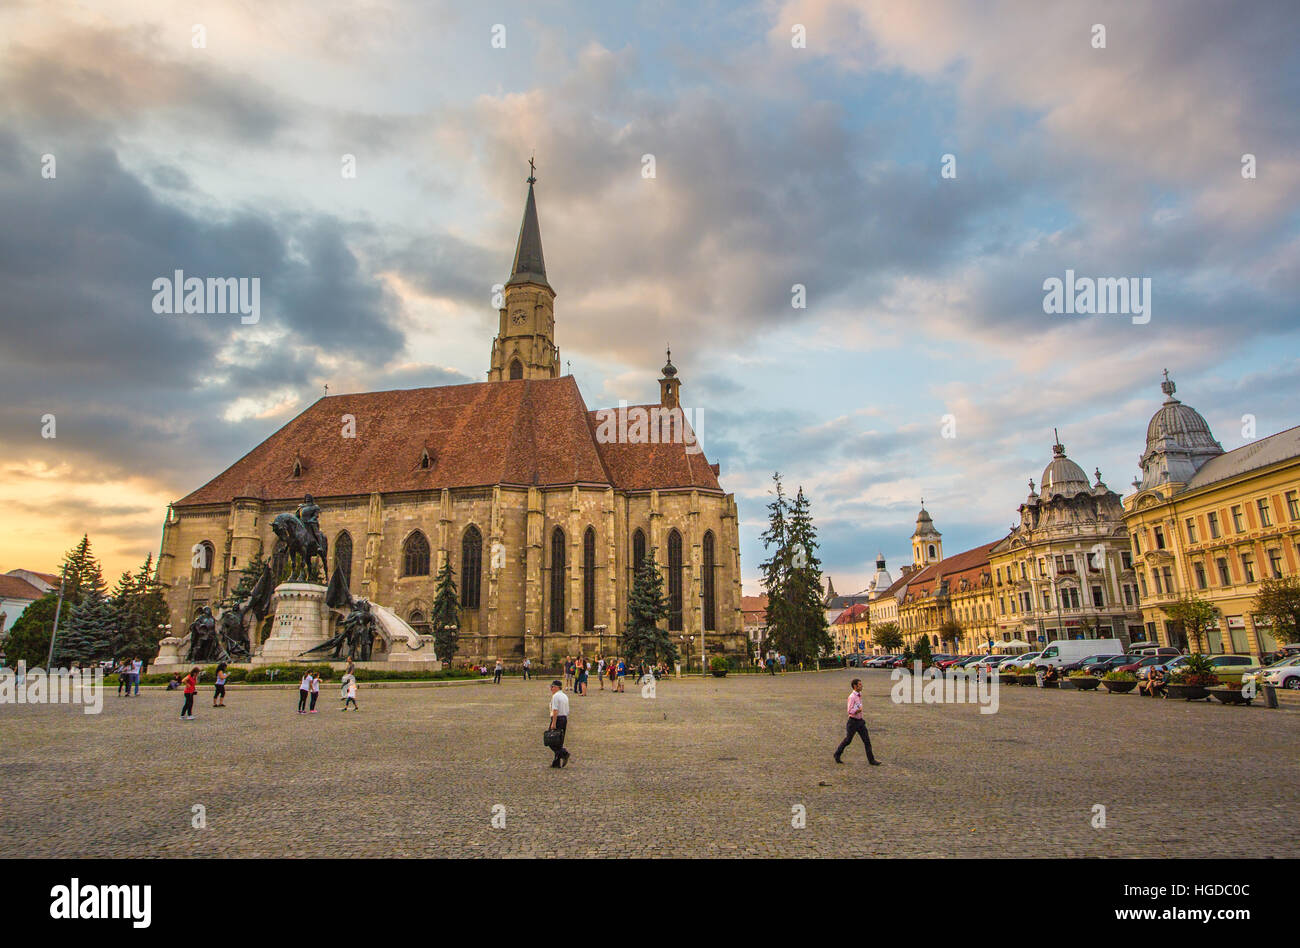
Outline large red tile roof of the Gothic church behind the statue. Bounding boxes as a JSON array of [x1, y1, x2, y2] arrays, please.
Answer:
[[176, 376, 722, 507]]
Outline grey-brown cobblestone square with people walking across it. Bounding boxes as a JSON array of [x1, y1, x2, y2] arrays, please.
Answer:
[[0, 670, 1300, 857]]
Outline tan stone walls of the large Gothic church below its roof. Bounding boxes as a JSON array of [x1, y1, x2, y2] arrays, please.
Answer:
[[160, 486, 744, 663]]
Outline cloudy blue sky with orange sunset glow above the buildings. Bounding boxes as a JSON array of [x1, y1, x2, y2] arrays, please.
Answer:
[[0, 0, 1300, 592]]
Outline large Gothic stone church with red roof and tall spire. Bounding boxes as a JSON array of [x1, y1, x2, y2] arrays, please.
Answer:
[[159, 177, 745, 662]]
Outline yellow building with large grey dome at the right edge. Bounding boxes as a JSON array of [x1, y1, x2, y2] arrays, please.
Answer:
[[1123, 372, 1300, 658]]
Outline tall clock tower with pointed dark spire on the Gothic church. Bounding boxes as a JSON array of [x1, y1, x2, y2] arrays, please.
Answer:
[[488, 161, 560, 382]]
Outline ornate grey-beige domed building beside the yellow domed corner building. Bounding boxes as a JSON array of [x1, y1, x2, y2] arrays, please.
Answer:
[[984, 436, 1144, 648]]
